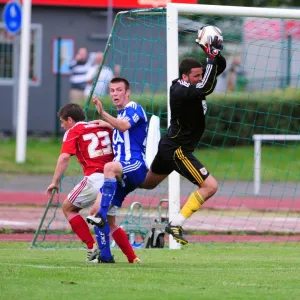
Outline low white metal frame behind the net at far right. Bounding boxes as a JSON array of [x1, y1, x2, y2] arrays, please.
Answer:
[[253, 134, 300, 196]]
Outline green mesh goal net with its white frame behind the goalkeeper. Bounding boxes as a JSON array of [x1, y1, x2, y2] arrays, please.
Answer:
[[32, 4, 300, 248]]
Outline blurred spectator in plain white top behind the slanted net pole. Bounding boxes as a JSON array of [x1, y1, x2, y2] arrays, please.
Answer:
[[84, 52, 121, 97]]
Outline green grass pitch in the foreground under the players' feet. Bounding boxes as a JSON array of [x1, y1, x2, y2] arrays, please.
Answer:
[[0, 242, 300, 300]]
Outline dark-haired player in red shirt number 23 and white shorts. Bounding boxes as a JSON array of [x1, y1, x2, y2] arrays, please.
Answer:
[[47, 103, 114, 261]]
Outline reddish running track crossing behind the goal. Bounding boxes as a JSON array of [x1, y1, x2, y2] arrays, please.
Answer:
[[0, 191, 300, 242]]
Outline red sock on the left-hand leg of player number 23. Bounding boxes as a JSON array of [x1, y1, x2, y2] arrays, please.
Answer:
[[68, 214, 95, 249]]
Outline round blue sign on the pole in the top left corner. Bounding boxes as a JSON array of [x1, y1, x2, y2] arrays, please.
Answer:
[[2, 2, 22, 34]]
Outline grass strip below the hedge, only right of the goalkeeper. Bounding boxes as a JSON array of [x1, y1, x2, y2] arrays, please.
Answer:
[[195, 144, 300, 182]]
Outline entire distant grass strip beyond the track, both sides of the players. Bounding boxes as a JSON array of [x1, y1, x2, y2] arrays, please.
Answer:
[[0, 139, 300, 182]]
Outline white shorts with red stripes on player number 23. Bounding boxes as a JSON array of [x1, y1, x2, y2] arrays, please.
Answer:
[[68, 173, 104, 208]]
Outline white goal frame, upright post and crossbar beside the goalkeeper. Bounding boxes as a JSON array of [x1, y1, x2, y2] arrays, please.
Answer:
[[166, 3, 300, 249]]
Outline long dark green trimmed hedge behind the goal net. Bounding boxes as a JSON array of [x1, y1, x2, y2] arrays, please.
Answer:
[[86, 88, 300, 147]]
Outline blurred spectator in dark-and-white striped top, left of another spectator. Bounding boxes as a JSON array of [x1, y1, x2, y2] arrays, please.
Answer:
[[69, 48, 94, 104]]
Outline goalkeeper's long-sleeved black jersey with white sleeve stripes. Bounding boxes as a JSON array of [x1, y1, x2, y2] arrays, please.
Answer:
[[162, 56, 226, 151]]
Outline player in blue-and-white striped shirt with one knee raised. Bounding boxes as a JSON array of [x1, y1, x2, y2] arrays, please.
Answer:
[[87, 77, 148, 263]]
